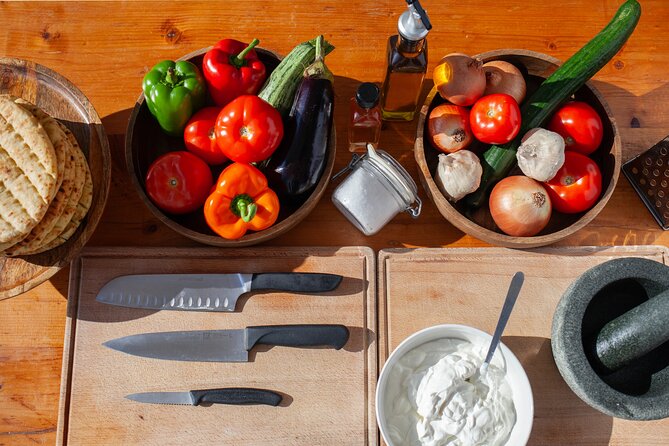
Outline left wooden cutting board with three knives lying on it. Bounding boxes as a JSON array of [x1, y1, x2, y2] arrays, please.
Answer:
[[57, 247, 378, 446]]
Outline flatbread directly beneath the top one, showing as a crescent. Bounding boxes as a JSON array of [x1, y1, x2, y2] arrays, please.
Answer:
[[5, 99, 76, 256]]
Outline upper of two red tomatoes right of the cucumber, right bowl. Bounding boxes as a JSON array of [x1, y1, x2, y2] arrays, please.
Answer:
[[548, 101, 604, 155]]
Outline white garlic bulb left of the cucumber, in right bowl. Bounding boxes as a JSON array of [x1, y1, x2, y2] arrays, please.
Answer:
[[435, 150, 483, 202]]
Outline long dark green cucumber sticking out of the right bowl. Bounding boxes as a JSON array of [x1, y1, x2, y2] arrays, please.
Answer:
[[466, 0, 641, 209]]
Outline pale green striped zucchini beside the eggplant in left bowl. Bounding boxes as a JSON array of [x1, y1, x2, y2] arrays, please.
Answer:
[[258, 38, 334, 118]]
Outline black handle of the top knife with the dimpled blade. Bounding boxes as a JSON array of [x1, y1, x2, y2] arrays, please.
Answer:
[[251, 273, 342, 293]]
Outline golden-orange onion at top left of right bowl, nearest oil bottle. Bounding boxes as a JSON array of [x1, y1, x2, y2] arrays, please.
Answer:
[[432, 53, 486, 106]]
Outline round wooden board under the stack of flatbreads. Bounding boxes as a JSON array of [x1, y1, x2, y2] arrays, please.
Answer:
[[0, 58, 111, 299]]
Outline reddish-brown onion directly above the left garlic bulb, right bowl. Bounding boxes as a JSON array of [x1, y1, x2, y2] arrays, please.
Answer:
[[427, 104, 474, 153]]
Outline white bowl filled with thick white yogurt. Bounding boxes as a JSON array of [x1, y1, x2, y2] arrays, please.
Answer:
[[376, 325, 534, 446]]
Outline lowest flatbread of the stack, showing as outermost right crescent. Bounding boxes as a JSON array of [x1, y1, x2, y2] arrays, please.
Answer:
[[32, 123, 93, 254]]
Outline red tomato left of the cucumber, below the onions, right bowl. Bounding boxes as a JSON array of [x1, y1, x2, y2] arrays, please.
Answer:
[[469, 93, 520, 144]]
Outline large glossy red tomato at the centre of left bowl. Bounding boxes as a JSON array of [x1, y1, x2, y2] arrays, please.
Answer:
[[215, 95, 283, 163]]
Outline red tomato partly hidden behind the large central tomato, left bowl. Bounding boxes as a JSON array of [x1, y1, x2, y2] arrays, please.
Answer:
[[184, 107, 227, 166]]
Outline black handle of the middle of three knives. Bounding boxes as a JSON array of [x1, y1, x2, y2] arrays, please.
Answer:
[[246, 325, 349, 350]]
